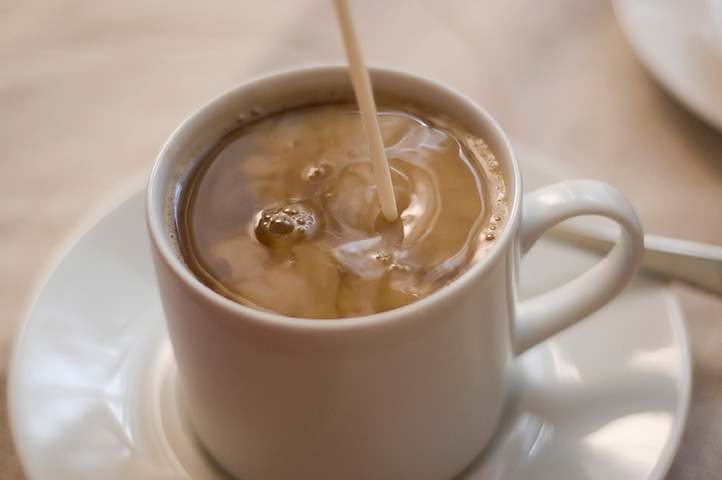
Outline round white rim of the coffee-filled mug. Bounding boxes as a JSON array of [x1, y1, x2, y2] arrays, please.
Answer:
[[145, 65, 522, 331]]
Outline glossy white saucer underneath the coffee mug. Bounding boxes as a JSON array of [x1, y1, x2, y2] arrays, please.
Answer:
[[9, 152, 691, 480]]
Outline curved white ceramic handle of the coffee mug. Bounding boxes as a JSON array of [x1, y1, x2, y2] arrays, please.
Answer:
[[514, 180, 644, 355]]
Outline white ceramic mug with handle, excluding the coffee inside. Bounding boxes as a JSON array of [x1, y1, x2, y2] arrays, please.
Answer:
[[147, 67, 643, 480]]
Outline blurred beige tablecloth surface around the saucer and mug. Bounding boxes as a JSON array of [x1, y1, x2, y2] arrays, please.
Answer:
[[0, 0, 722, 480]]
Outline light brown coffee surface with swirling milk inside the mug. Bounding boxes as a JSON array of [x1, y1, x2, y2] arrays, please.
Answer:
[[175, 104, 507, 318]]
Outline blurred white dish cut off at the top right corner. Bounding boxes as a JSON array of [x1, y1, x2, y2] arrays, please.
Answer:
[[614, 0, 722, 129]]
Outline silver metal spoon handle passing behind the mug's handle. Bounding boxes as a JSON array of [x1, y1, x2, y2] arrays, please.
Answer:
[[550, 224, 722, 295]]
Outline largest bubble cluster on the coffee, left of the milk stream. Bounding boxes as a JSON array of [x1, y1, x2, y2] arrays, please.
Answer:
[[256, 203, 318, 247]]
